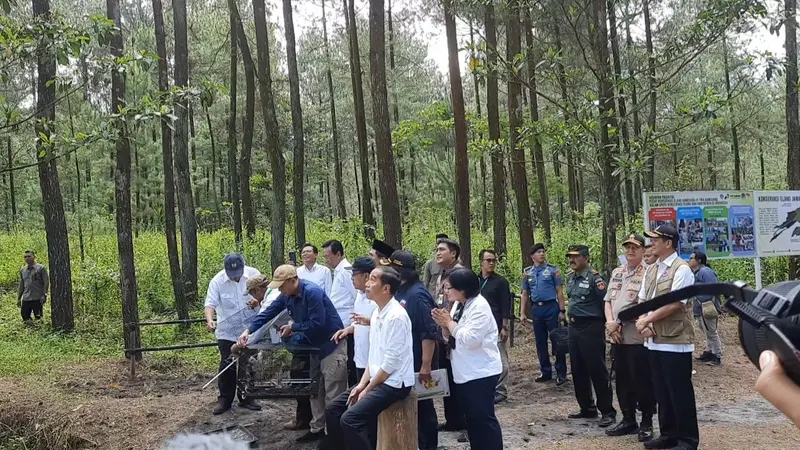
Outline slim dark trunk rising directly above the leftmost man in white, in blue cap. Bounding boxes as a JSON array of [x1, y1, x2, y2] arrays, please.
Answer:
[[228, 0, 243, 252]]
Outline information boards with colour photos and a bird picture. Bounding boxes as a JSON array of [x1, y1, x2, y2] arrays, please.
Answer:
[[643, 191, 800, 259]]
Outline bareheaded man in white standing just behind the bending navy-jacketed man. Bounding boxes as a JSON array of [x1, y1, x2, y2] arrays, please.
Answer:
[[322, 240, 358, 386]]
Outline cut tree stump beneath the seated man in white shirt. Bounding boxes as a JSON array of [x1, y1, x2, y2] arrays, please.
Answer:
[[378, 389, 418, 450]]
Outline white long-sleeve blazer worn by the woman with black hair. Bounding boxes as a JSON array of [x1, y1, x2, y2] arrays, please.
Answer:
[[450, 294, 503, 384]]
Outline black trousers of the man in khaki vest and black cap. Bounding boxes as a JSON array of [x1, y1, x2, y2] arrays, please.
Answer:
[[649, 350, 700, 449]]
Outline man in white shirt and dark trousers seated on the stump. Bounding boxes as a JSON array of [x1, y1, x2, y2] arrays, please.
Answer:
[[318, 267, 414, 450]]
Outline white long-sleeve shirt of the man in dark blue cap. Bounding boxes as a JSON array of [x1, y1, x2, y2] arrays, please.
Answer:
[[204, 266, 261, 341]]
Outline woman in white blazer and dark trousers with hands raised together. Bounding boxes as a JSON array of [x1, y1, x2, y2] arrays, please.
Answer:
[[431, 268, 503, 450]]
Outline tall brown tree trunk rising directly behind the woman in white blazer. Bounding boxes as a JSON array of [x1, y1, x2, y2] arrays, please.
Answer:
[[444, 0, 472, 267]]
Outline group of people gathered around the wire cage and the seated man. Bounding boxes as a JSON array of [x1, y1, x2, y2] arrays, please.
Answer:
[[205, 235, 512, 450]]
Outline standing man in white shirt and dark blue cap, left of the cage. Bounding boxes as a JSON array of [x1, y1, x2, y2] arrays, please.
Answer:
[[203, 253, 261, 415]]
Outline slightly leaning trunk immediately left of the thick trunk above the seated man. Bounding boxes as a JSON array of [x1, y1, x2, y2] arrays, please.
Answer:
[[342, 0, 377, 239]]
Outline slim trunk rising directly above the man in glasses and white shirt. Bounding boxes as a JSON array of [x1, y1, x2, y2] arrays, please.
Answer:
[[283, 0, 306, 249]]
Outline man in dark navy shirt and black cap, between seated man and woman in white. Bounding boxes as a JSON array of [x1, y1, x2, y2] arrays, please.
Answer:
[[390, 250, 441, 450]]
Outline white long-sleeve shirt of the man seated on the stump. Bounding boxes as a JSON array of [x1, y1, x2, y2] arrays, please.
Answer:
[[369, 298, 412, 388]]
